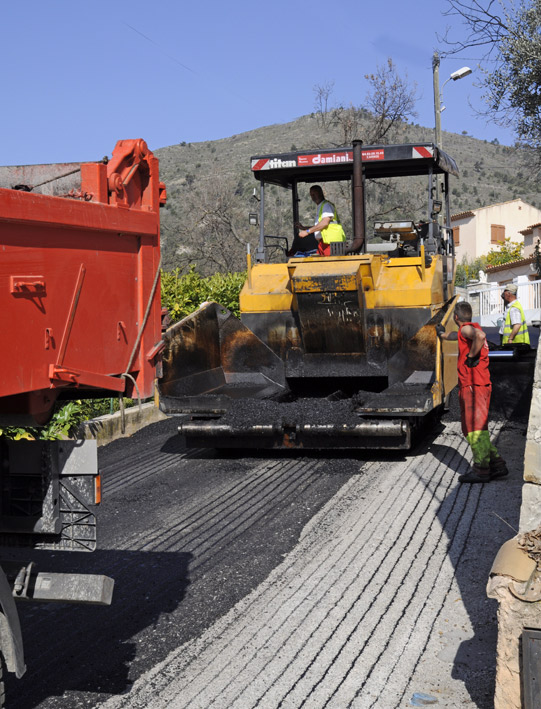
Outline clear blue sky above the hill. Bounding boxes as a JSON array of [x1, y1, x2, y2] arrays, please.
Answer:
[[0, 0, 514, 165]]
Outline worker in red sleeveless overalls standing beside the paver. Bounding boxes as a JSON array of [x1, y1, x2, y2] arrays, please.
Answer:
[[436, 302, 509, 483]]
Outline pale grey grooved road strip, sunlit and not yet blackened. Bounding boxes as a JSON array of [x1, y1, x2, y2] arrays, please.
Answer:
[[99, 424, 480, 709]]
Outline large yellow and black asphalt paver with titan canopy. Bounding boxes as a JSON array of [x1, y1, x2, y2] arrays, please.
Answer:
[[159, 141, 458, 449]]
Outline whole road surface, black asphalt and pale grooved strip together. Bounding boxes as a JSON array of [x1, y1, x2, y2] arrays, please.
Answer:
[[7, 416, 525, 709]]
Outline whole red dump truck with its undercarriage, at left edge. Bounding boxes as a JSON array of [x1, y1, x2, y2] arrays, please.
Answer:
[[0, 140, 166, 706]]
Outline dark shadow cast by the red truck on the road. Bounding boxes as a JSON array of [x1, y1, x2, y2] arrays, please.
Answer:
[[7, 551, 191, 709]]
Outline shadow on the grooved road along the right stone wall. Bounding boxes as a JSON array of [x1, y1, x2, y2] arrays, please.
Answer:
[[430, 396, 529, 709]]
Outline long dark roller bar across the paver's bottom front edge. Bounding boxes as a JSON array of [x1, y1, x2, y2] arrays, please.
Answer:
[[179, 419, 413, 450]]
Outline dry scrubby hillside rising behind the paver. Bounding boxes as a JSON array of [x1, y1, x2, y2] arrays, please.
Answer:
[[154, 111, 541, 275]]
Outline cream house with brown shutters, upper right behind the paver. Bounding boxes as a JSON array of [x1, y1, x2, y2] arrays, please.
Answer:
[[451, 199, 541, 263]]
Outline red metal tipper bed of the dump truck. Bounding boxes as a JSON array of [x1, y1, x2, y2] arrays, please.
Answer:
[[0, 140, 166, 425]]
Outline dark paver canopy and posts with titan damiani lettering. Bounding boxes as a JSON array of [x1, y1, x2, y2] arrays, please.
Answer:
[[251, 141, 458, 261]]
